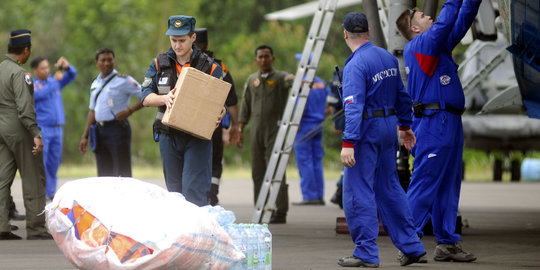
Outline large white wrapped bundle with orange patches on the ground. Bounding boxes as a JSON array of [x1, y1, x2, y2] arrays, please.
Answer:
[[46, 177, 244, 270]]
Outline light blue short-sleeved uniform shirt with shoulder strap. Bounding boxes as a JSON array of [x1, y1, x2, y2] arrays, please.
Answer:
[[89, 69, 141, 122]]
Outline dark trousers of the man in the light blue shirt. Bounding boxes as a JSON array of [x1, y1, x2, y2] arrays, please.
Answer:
[[95, 120, 131, 177]]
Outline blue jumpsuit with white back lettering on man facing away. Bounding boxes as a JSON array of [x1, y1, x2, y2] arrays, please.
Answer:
[[343, 42, 425, 264]]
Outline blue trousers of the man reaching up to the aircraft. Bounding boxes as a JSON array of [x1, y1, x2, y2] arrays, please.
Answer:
[[407, 111, 463, 244]]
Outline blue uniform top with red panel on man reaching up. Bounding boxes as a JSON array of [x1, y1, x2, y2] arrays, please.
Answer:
[[403, 0, 481, 108]]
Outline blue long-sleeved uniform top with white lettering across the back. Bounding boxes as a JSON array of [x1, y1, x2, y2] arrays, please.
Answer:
[[343, 41, 412, 142]]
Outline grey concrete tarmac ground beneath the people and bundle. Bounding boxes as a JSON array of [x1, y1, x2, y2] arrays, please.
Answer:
[[0, 179, 540, 270]]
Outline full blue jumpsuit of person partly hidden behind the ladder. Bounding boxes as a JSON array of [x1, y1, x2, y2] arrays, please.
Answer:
[[294, 76, 330, 200]]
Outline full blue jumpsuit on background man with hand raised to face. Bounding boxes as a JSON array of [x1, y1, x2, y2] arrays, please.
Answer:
[[34, 65, 77, 198]]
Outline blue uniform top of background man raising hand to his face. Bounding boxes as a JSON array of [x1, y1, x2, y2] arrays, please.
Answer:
[[34, 65, 77, 127]]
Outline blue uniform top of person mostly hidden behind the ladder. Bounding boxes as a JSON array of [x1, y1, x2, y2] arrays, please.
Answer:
[[301, 76, 330, 123]]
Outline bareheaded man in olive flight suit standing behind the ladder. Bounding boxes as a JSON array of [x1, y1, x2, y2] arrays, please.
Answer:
[[238, 45, 293, 223]]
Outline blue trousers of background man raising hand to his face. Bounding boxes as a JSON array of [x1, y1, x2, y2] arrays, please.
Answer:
[[41, 125, 64, 198]]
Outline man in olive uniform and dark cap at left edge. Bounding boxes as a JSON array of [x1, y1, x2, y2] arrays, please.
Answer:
[[0, 30, 52, 240]]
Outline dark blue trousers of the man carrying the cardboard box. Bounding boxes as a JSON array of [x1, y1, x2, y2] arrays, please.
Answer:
[[159, 134, 212, 206]]
